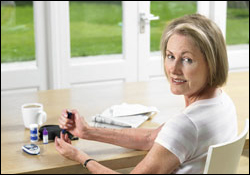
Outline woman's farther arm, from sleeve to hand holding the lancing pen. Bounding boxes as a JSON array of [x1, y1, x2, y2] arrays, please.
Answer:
[[59, 110, 163, 150]]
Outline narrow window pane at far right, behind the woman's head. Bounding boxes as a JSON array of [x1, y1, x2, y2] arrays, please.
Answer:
[[226, 1, 249, 45]]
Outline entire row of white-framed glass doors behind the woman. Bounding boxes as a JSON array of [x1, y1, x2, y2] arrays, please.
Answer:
[[1, 1, 249, 92]]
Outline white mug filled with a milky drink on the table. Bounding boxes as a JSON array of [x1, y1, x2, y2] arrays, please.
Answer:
[[22, 103, 47, 129]]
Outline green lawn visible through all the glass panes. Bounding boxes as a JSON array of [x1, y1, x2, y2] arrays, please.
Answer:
[[1, 1, 249, 63]]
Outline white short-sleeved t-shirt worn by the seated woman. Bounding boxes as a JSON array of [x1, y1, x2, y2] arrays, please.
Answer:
[[155, 91, 238, 174]]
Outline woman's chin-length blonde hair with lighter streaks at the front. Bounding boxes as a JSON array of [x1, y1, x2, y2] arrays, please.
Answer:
[[161, 14, 228, 87]]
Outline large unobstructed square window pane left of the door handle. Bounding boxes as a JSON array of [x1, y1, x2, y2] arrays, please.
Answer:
[[70, 1, 122, 57]]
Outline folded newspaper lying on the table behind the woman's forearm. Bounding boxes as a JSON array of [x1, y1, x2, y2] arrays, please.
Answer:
[[92, 103, 159, 128]]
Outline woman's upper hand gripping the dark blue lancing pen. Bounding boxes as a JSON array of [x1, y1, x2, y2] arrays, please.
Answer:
[[59, 109, 90, 139]]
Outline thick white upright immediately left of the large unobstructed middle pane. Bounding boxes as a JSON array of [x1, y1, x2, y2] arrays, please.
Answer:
[[46, 1, 70, 89]]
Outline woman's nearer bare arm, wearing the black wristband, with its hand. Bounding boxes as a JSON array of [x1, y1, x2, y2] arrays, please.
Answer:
[[55, 133, 180, 174]]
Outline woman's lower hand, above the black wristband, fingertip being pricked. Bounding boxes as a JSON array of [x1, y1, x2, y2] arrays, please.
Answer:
[[55, 132, 89, 163]]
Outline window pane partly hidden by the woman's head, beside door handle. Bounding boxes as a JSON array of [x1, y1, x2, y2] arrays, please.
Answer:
[[150, 1, 197, 51]]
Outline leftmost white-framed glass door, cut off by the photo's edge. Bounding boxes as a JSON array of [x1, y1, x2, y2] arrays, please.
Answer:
[[1, 1, 47, 94]]
